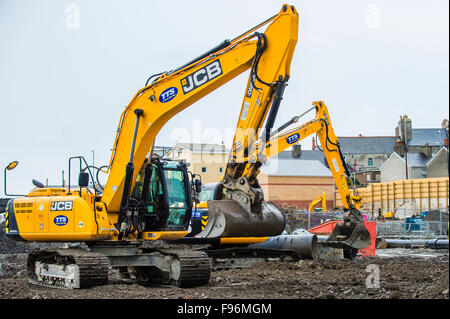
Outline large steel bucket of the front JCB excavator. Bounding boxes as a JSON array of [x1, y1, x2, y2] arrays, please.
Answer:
[[195, 200, 285, 238]]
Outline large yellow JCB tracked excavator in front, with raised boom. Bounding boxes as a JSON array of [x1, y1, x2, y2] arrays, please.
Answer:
[[6, 5, 299, 288]]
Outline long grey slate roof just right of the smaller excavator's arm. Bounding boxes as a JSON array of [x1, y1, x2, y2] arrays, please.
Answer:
[[338, 136, 396, 155]]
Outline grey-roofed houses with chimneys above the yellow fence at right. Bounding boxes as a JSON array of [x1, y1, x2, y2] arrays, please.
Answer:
[[339, 116, 448, 185]]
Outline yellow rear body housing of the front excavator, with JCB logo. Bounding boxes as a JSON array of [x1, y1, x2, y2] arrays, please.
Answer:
[[6, 189, 116, 241]]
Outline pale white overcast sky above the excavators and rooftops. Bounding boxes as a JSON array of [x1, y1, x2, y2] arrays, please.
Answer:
[[0, 0, 449, 196]]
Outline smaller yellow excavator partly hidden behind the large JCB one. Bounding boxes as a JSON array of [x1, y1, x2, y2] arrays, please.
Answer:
[[185, 101, 370, 250]]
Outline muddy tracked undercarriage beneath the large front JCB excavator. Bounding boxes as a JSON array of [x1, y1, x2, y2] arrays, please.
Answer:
[[27, 241, 212, 289]]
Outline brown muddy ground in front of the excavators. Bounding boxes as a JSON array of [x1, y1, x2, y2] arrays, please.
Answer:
[[0, 253, 449, 299]]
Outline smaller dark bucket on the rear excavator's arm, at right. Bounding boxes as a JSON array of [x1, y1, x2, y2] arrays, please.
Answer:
[[325, 208, 370, 249]]
